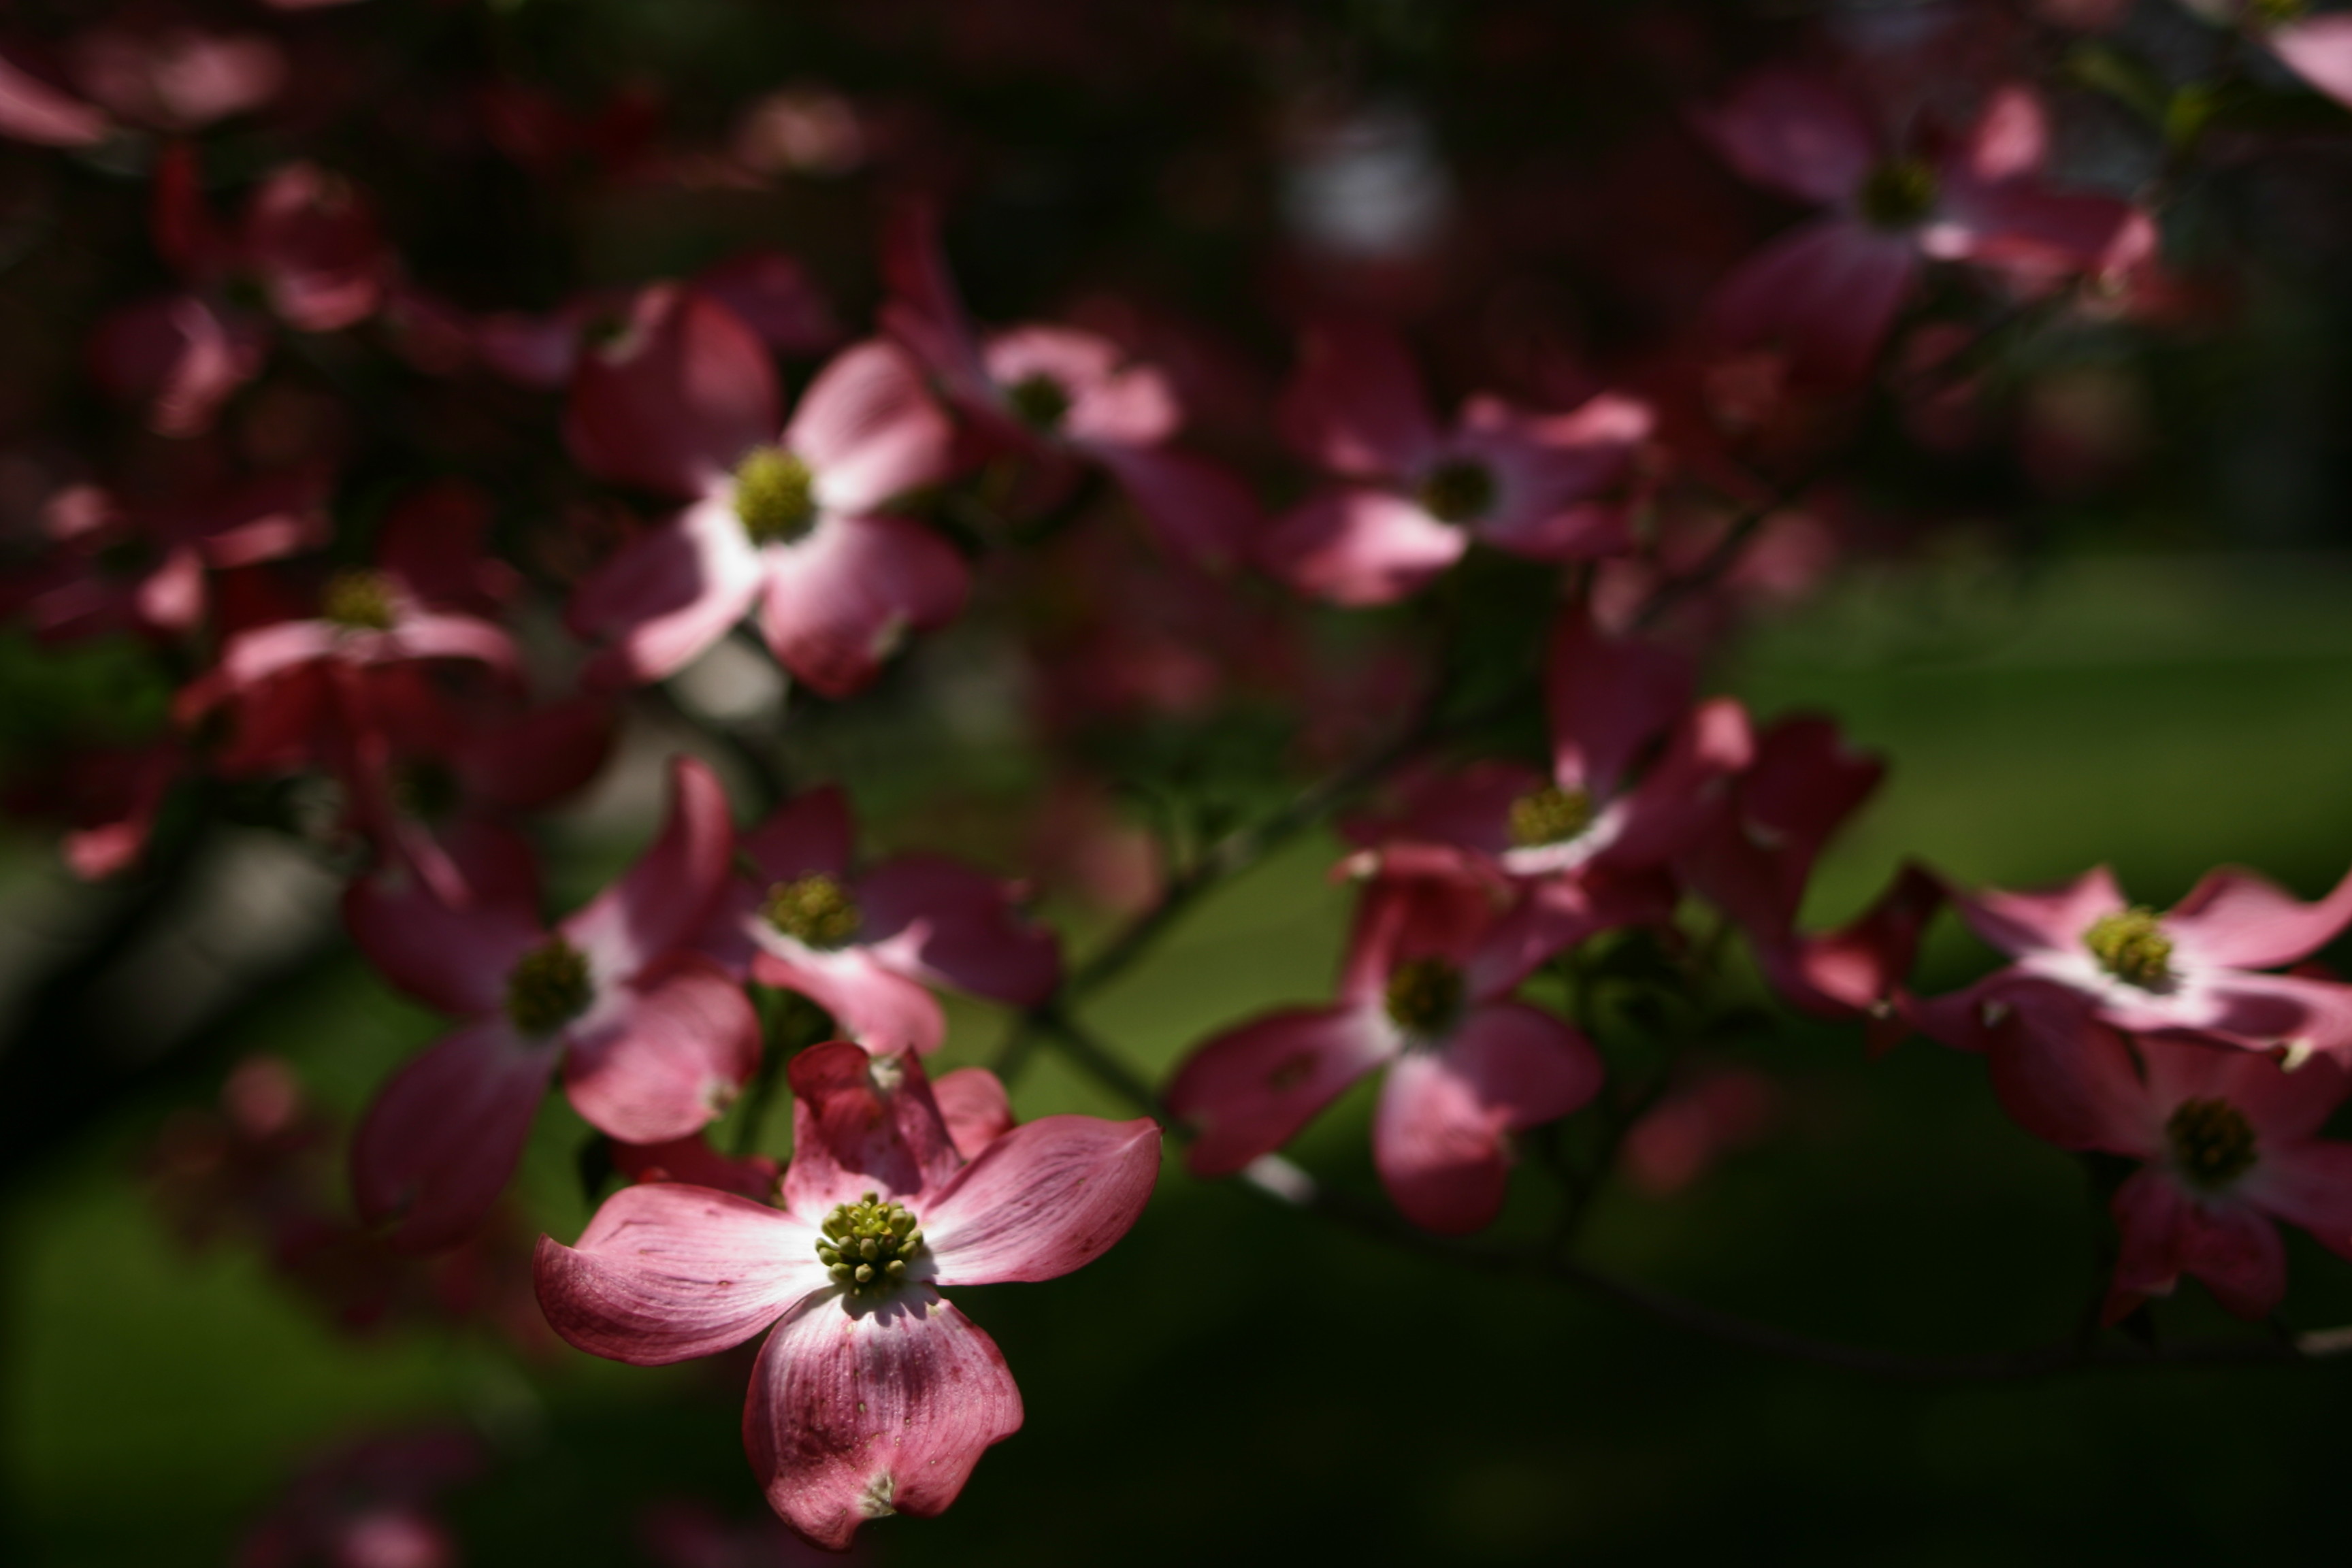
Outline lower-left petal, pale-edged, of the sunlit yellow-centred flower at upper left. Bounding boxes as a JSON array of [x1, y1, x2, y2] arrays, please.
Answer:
[[569, 503, 762, 687]]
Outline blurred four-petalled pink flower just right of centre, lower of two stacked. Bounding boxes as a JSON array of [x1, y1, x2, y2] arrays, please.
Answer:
[[1166, 877, 1602, 1234]]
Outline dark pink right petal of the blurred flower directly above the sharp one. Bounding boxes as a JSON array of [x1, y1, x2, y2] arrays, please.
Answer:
[[856, 855, 1061, 1006]]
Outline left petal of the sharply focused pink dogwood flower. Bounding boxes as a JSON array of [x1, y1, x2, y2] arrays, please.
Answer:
[[532, 1182, 832, 1366]]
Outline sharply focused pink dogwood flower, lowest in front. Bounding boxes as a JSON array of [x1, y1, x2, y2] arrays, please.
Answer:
[[538, 1041, 1160, 1549]]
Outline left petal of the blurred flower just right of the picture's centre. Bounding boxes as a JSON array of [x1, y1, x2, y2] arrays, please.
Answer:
[[1166, 1006, 1394, 1175]]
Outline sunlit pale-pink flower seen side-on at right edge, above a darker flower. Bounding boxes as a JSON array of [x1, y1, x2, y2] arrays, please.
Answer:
[[1914, 868, 2352, 1060]]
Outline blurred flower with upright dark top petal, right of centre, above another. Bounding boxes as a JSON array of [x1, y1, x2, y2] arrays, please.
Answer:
[[1350, 611, 1754, 893]]
